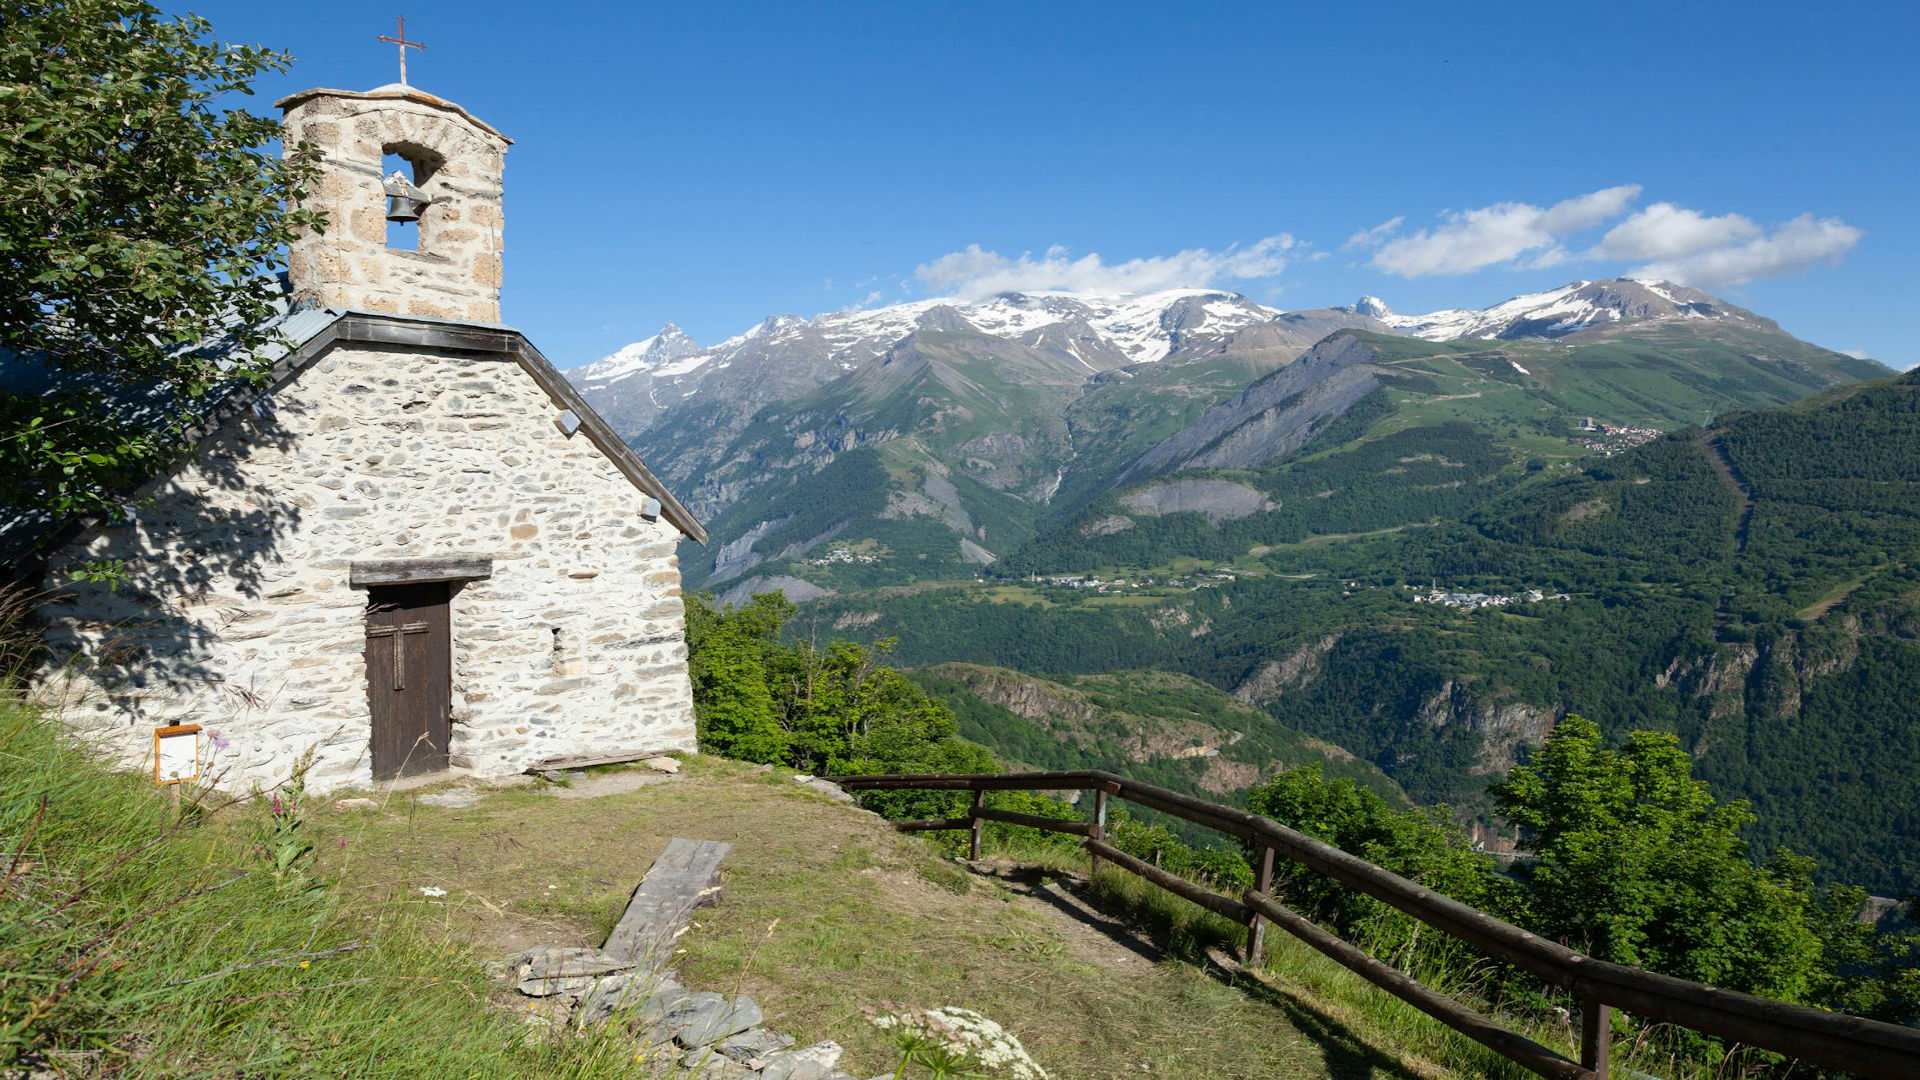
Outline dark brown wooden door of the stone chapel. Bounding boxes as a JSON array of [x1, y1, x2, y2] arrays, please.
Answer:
[[367, 582, 453, 780]]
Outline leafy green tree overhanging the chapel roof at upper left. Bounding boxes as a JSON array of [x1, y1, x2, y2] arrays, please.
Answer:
[[0, 0, 323, 513]]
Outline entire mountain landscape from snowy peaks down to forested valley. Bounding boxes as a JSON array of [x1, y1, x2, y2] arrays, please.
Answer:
[[574, 281, 1920, 890]]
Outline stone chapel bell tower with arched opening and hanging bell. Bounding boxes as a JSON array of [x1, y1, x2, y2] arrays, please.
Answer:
[[278, 83, 513, 323]]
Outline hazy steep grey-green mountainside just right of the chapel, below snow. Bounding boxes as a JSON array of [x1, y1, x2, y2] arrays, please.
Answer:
[[684, 331, 1085, 598]]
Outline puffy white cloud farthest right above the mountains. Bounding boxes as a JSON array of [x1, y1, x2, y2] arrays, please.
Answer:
[[1601, 208, 1864, 288]]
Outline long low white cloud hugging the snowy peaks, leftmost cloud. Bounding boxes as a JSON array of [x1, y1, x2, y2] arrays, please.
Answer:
[[914, 233, 1302, 300]]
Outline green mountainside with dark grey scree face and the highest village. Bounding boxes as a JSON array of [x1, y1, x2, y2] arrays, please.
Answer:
[[1004, 321, 1885, 573]]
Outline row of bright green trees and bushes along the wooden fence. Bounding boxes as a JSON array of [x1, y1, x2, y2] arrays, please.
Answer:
[[687, 576, 1920, 1053]]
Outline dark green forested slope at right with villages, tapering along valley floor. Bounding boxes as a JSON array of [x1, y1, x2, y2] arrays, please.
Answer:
[[787, 365, 1920, 894]]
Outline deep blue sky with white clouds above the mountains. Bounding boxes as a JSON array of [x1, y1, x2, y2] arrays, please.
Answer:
[[182, 0, 1920, 367]]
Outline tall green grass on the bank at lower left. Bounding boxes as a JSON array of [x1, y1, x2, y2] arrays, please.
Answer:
[[0, 703, 651, 1080]]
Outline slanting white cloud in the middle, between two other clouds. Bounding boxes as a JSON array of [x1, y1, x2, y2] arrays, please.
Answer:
[[1371, 184, 1640, 277]]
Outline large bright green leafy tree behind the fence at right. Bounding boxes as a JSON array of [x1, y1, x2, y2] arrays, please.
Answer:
[[1494, 715, 1824, 1001]]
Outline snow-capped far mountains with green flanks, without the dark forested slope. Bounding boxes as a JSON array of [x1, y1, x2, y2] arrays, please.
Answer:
[[572, 279, 1885, 600]]
